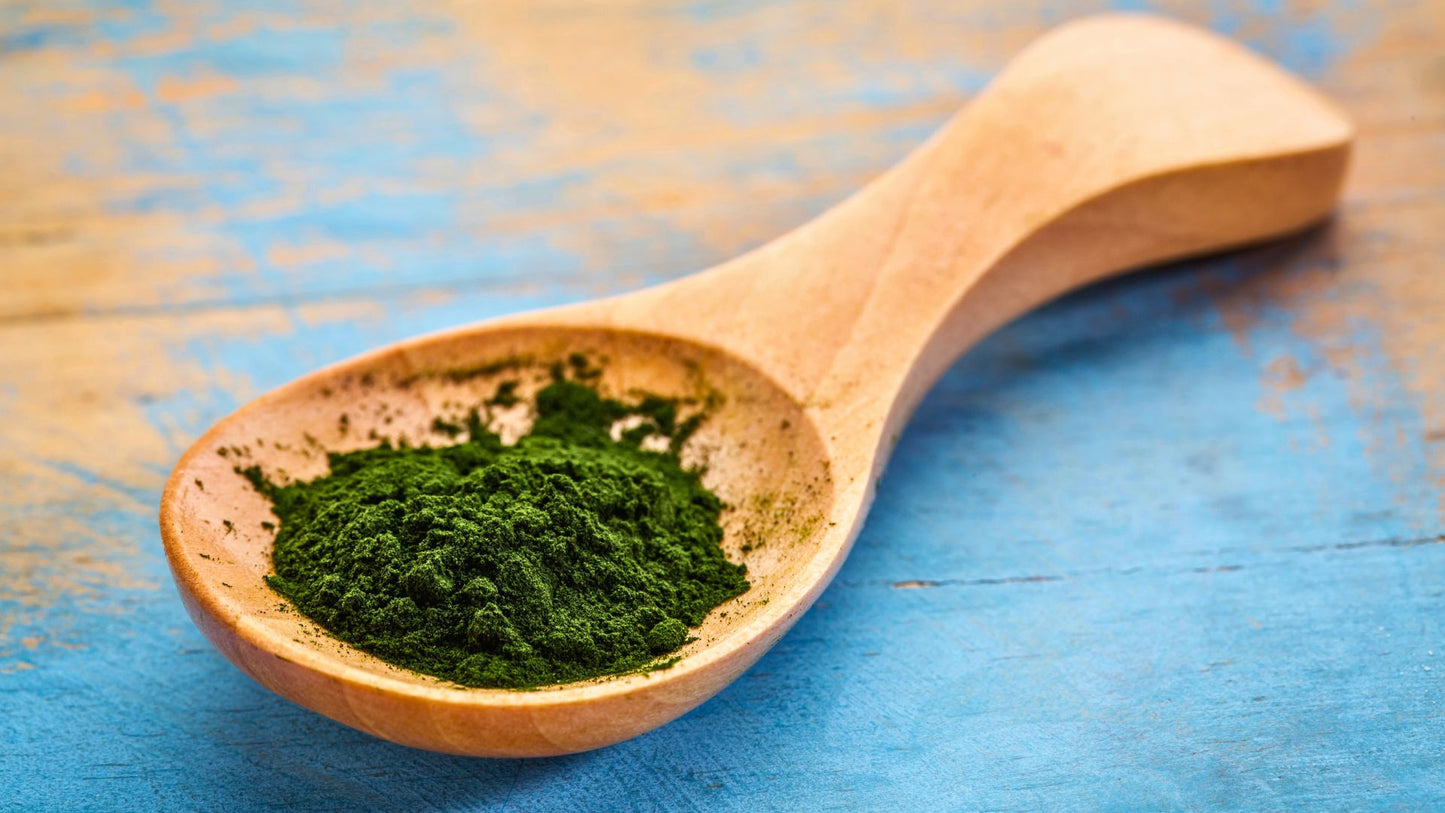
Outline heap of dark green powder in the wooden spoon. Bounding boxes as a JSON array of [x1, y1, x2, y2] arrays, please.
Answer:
[[246, 377, 749, 689]]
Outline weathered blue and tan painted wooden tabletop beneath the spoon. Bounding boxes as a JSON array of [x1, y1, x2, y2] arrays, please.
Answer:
[[0, 0, 1445, 810]]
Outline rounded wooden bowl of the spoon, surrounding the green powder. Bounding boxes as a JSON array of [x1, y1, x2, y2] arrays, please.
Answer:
[[162, 326, 841, 755]]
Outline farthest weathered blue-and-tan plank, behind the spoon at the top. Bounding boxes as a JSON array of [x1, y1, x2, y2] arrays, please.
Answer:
[[0, 3, 1441, 318]]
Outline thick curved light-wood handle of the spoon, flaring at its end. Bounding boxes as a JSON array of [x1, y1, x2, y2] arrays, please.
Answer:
[[572, 16, 1353, 470]]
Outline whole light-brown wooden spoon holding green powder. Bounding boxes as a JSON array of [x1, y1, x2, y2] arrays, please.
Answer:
[[160, 16, 1353, 757]]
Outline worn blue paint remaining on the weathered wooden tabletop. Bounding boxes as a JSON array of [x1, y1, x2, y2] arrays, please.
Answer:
[[0, 3, 1445, 810]]
